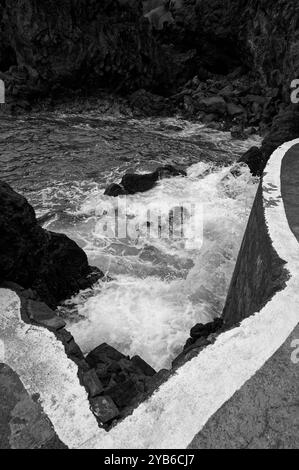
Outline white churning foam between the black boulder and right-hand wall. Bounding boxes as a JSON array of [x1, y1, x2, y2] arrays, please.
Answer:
[[58, 163, 256, 369]]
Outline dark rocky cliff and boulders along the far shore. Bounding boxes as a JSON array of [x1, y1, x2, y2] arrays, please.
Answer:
[[0, 0, 299, 170]]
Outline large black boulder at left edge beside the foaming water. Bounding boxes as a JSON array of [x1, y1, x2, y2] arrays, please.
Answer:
[[0, 182, 103, 306]]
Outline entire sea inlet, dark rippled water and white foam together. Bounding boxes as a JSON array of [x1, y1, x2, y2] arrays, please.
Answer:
[[0, 112, 259, 370]]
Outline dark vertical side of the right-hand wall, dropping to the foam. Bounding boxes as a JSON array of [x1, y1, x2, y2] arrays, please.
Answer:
[[223, 184, 288, 328]]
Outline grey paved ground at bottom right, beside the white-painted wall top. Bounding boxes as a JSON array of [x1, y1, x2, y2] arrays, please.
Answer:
[[189, 327, 299, 449]]
